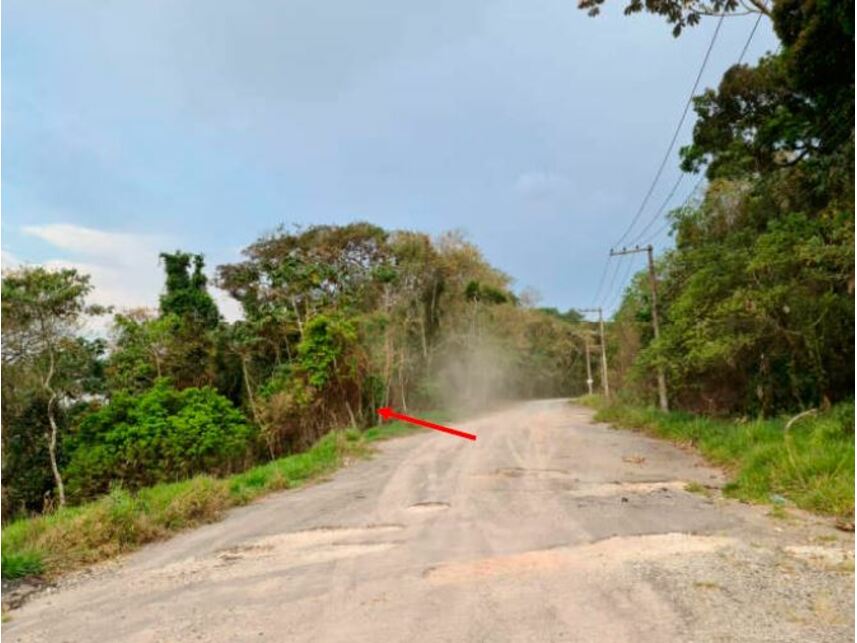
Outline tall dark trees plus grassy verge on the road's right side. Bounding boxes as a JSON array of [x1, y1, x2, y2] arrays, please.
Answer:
[[580, 0, 855, 524]]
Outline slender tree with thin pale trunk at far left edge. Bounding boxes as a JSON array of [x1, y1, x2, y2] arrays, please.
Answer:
[[2, 267, 103, 506]]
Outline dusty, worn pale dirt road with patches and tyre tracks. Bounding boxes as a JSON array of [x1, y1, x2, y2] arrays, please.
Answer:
[[3, 400, 854, 642]]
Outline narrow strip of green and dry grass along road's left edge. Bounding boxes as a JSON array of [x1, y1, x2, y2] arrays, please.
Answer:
[[2, 413, 445, 578]]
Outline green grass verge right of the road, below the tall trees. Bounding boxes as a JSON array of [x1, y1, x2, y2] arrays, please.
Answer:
[[577, 398, 854, 518]]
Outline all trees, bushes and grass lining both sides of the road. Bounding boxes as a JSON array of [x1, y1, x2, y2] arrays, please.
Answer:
[[2, 0, 855, 588]]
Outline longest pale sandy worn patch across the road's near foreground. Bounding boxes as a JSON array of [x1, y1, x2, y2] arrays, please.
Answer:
[[423, 533, 736, 583]]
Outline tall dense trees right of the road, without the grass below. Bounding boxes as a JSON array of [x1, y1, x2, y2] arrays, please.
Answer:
[[596, 0, 854, 415]]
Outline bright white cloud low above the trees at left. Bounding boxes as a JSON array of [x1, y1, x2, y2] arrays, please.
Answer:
[[21, 223, 241, 320]]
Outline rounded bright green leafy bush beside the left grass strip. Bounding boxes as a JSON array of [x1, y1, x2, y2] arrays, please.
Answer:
[[65, 379, 256, 499]]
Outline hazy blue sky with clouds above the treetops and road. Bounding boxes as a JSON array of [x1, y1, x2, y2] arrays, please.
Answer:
[[2, 0, 776, 316]]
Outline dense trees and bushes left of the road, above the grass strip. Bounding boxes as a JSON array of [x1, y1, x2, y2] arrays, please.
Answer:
[[3, 223, 585, 518]]
